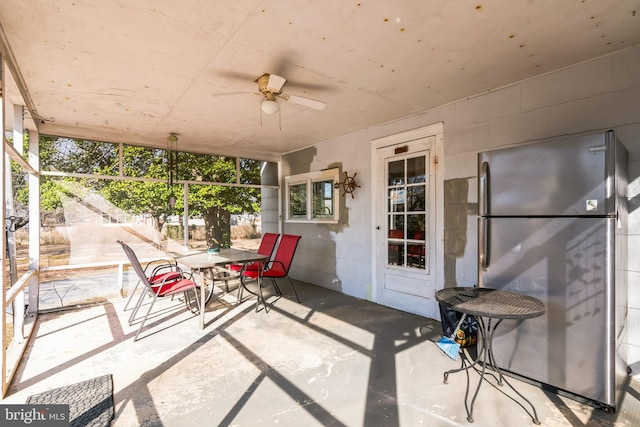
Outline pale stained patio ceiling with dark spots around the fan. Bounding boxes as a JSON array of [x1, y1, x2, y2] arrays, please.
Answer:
[[0, 0, 640, 157]]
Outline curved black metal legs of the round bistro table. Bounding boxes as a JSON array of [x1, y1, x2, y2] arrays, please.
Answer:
[[444, 316, 540, 425]]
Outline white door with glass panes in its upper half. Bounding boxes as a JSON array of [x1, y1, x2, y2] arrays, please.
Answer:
[[374, 128, 442, 318]]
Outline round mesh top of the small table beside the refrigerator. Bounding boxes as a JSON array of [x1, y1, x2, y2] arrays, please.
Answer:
[[436, 287, 545, 319]]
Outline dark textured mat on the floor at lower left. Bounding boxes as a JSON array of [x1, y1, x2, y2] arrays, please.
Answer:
[[27, 375, 114, 427]]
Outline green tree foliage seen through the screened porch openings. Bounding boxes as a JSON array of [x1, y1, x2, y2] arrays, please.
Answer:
[[40, 136, 261, 246]]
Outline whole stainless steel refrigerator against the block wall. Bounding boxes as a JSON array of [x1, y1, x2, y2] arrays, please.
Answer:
[[478, 131, 628, 409]]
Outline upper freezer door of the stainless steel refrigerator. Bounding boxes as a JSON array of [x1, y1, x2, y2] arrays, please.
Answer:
[[478, 131, 616, 216]]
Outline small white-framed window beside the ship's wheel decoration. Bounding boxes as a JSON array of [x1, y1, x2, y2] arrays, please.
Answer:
[[285, 168, 340, 223]]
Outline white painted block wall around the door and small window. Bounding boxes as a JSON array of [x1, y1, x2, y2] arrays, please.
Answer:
[[283, 47, 640, 372]]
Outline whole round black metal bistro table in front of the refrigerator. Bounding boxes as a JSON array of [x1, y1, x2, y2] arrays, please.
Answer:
[[436, 287, 545, 424]]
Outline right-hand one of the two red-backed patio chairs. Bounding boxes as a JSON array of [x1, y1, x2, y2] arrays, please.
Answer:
[[241, 234, 301, 312]]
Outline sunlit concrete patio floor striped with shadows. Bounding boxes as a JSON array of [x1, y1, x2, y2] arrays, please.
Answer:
[[2, 282, 640, 427]]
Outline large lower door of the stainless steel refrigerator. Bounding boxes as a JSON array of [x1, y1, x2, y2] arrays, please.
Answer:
[[479, 218, 615, 405]]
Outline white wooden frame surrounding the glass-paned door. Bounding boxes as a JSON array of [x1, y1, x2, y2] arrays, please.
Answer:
[[371, 122, 444, 319]]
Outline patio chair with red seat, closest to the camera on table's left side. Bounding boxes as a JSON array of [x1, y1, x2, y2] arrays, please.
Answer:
[[118, 240, 199, 341]]
